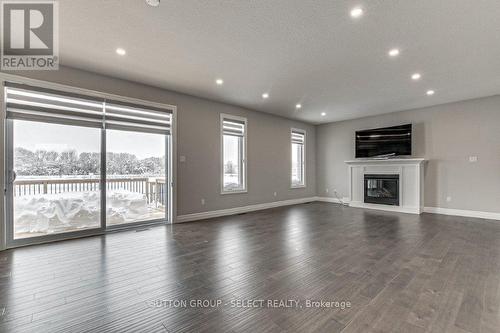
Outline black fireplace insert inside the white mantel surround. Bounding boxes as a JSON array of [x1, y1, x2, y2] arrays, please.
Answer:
[[365, 174, 399, 206]]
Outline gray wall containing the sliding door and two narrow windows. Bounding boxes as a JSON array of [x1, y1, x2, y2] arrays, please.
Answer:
[[0, 67, 316, 231]]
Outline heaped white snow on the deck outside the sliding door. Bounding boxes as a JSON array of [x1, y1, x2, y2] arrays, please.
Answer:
[[14, 190, 165, 237]]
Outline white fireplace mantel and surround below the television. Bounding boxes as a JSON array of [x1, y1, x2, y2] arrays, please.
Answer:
[[345, 158, 426, 214]]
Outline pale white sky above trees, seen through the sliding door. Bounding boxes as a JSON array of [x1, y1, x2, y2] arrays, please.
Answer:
[[14, 120, 165, 159]]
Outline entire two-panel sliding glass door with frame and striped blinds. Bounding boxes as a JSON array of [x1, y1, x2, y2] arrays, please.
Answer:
[[5, 83, 172, 246]]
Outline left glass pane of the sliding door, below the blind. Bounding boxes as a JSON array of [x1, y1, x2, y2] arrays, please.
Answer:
[[10, 120, 101, 239]]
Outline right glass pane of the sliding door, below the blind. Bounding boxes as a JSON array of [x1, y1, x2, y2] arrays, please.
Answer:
[[106, 130, 168, 226]]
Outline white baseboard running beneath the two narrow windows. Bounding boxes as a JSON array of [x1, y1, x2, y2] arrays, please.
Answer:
[[175, 197, 317, 223]]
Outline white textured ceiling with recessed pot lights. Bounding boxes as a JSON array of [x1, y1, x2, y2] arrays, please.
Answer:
[[59, 0, 500, 123]]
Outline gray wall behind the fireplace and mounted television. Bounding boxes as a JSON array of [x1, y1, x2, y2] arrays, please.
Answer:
[[316, 96, 500, 212]]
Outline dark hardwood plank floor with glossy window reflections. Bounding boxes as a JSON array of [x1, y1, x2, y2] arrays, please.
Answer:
[[0, 203, 500, 333]]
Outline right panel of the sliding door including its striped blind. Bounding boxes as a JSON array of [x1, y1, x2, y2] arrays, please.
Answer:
[[105, 100, 172, 227]]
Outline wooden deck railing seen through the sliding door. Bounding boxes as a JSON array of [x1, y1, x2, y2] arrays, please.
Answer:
[[14, 177, 166, 206]]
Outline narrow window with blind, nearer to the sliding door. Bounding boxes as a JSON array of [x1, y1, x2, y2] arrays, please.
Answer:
[[221, 114, 247, 193]]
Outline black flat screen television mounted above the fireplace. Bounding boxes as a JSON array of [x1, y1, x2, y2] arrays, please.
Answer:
[[356, 124, 412, 158]]
